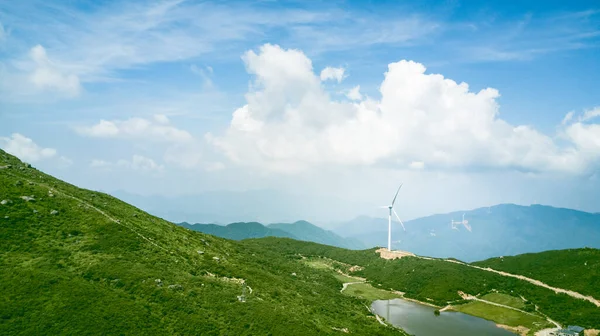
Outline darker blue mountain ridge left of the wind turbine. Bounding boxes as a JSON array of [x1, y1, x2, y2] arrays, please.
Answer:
[[179, 221, 367, 249]]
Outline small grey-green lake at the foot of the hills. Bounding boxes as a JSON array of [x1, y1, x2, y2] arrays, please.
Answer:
[[371, 299, 515, 336]]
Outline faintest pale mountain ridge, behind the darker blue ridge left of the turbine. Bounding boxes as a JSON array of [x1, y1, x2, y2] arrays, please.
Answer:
[[110, 189, 370, 224]]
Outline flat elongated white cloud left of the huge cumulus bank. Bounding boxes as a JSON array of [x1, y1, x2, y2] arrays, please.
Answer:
[[76, 115, 193, 143]]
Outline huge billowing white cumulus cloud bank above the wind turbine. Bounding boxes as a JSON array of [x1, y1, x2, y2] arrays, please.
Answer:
[[207, 44, 600, 173]]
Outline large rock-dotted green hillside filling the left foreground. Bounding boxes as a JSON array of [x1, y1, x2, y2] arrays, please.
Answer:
[[0, 151, 398, 335]]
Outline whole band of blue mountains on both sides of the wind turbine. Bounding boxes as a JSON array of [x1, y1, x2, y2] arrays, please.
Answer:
[[181, 204, 600, 262]]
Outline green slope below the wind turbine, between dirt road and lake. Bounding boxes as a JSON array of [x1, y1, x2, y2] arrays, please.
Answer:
[[245, 238, 600, 328]]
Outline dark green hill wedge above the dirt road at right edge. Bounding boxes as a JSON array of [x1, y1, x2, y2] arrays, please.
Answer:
[[473, 248, 600, 299]]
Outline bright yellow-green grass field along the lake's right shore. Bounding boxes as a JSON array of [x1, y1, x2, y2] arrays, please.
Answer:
[[453, 301, 552, 329]]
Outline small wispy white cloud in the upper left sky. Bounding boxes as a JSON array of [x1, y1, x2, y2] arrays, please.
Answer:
[[29, 45, 81, 96]]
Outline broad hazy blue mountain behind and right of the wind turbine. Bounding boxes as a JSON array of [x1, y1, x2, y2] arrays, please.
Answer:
[[334, 204, 600, 261]]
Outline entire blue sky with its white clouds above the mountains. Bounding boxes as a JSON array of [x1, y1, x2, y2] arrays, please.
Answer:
[[0, 0, 600, 223]]
